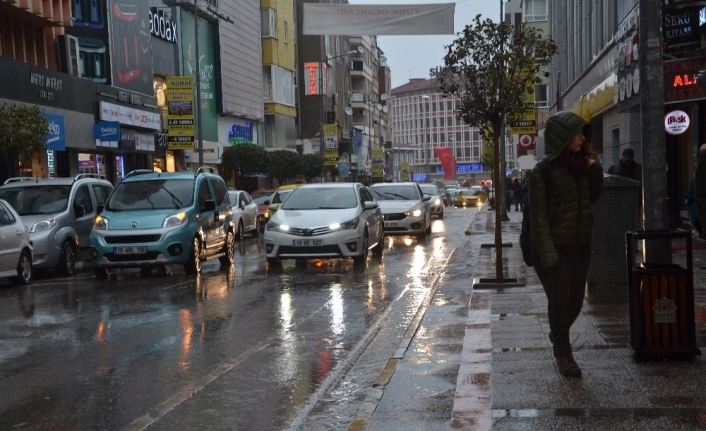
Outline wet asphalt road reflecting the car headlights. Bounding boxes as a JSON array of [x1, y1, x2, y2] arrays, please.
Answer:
[[0, 207, 476, 430]]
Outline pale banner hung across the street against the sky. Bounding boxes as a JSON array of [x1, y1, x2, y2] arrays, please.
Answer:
[[304, 3, 456, 36]]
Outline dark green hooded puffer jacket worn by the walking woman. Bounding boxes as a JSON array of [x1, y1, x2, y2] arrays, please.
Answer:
[[529, 111, 603, 269]]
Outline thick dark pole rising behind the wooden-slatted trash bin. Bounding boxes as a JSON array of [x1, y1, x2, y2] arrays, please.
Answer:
[[638, 0, 671, 263]]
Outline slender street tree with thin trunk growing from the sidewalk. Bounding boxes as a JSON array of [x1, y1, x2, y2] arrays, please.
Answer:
[[439, 15, 557, 283]]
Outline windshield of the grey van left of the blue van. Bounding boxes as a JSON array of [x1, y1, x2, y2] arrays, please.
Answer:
[[0, 184, 71, 216]]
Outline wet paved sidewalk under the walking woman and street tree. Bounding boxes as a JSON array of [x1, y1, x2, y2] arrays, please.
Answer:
[[361, 210, 706, 431]]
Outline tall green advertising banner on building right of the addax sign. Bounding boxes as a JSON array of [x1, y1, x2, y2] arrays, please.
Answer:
[[181, 9, 218, 142]]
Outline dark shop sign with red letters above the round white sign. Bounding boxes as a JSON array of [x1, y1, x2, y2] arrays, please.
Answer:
[[662, 57, 706, 104]]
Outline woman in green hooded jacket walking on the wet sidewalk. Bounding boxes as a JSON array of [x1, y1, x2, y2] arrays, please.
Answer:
[[528, 111, 603, 377]]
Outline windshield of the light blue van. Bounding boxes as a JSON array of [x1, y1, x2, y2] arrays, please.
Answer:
[[106, 179, 194, 211]]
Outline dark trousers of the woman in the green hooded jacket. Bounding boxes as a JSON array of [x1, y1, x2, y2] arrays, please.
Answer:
[[532, 244, 591, 348]]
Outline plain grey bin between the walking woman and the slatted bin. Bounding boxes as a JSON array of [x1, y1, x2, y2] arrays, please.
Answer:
[[586, 174, 640, 303]]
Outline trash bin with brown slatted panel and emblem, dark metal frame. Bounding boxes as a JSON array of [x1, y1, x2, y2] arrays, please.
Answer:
[[625, 229, 701, 360]]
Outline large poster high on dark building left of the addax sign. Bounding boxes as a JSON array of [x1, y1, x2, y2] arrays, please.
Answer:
[[109, 0, 154, 96]]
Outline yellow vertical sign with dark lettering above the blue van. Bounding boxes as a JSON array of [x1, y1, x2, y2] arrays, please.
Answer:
[[167, 76, 195, 150]]
